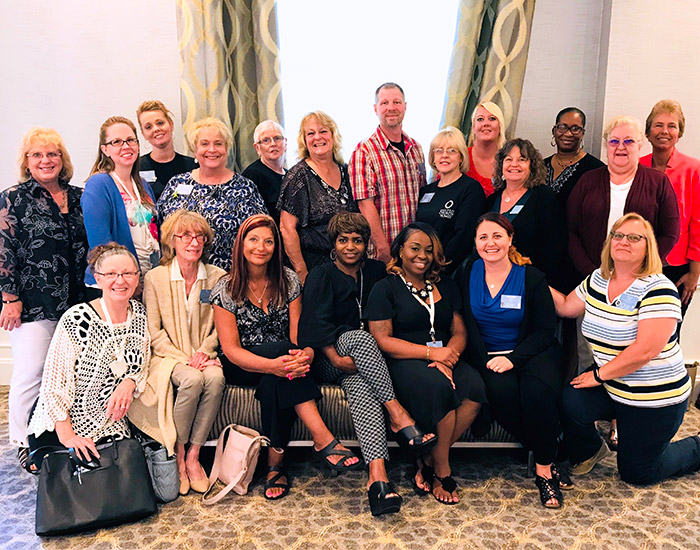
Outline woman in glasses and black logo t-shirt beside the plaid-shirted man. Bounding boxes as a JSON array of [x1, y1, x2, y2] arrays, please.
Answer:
[[416, 126, 486, 274]]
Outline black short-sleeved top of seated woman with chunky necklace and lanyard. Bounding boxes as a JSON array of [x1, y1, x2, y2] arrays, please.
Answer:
[[366, 275, 462, 346]]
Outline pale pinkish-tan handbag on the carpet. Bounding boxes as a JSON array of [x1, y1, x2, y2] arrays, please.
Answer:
[[202, 424, 270, 504]]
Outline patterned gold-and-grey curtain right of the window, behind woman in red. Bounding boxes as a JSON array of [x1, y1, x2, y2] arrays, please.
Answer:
[[441, 0, 535, 137]]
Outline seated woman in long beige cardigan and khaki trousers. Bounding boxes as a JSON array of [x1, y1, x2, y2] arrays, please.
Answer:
[[129, 210, 226, 495]]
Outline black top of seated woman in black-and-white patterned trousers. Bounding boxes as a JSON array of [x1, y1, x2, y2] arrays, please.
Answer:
[[299, 260, 386, 348]]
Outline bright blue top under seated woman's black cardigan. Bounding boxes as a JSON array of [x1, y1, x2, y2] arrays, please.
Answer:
[[469, 259, 525, 352]]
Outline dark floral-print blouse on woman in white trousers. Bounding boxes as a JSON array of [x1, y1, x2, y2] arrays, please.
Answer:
[[0, 179, 88, 323]]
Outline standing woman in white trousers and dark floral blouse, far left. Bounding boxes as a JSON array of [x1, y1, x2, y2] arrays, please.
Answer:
[[0, 128, 88, 468]]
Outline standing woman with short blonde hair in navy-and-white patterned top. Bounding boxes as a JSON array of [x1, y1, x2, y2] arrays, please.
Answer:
[[158, 117, 267, 270]]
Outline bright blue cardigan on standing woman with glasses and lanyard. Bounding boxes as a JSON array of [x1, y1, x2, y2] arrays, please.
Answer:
[[80, 173, 156, 285]]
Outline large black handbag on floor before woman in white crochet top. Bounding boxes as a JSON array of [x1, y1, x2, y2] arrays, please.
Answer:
[[35, 439, 157, 535]]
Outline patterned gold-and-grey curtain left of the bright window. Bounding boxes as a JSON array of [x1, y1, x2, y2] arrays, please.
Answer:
[[177, 0, 283, 171]]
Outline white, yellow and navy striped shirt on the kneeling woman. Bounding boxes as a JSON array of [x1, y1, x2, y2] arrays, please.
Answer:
[[576, 269, 690, 408]]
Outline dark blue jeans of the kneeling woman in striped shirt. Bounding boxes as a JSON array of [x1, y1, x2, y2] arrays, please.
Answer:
[[562, 386, 700, 485]]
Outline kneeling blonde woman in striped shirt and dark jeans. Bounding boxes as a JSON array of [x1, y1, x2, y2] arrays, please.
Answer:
[[552, 213, 700, 485]]
